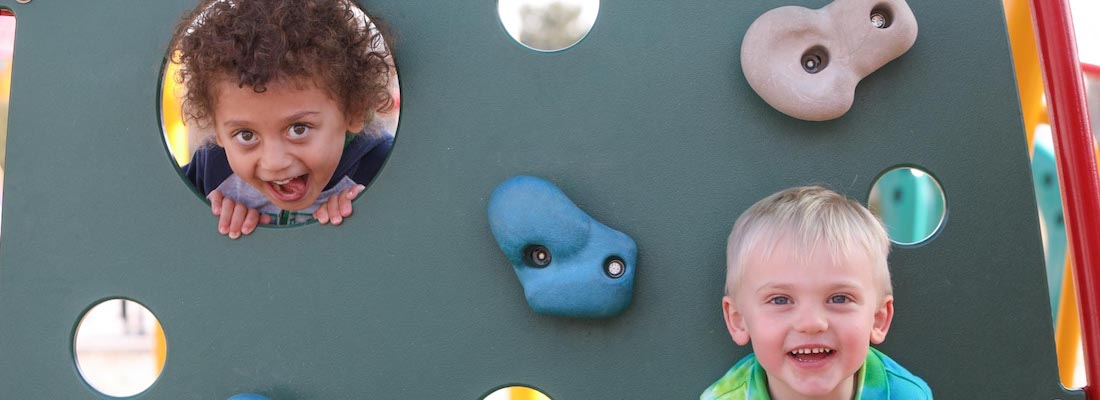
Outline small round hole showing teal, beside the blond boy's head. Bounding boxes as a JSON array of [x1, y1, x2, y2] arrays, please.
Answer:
[[867, 167, 947, 245]]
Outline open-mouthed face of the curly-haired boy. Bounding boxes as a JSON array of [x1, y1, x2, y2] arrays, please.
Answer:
[[212, 79, 363, 211]]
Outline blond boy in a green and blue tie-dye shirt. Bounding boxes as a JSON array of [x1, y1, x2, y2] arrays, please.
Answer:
[[700, 187, 932, 400]]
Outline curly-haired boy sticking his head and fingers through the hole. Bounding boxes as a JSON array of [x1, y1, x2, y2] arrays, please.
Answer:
[[171, 0, 394, 238]]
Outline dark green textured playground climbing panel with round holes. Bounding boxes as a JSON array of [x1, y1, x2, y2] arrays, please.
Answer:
[[0, 0, 1082, 400]]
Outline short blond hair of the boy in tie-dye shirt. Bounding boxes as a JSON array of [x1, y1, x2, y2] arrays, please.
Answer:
[[726, 186, 893, 295]]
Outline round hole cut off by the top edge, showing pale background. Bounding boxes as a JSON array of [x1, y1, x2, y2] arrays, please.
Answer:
[[496, 0, 600, 52]]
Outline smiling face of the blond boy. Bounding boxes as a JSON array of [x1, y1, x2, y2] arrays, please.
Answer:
[[723, 238, 893, 399]]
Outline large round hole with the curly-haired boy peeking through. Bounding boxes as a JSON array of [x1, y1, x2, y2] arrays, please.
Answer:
[[160, 0, 400, 225]]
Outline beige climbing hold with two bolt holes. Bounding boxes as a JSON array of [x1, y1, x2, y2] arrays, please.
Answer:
[[740, 0, 917, 121]]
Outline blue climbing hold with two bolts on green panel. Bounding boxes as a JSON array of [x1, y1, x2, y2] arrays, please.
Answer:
[[488, 176, 638, 318]]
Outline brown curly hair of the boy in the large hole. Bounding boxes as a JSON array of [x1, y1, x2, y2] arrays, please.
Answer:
[[169, 0, 394, 127]]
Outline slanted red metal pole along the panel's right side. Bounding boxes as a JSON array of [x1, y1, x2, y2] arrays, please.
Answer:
[[1031, 0, 1100, 400]]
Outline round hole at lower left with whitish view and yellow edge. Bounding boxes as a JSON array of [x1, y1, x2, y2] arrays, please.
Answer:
[[73, 299, 167, 397]]
